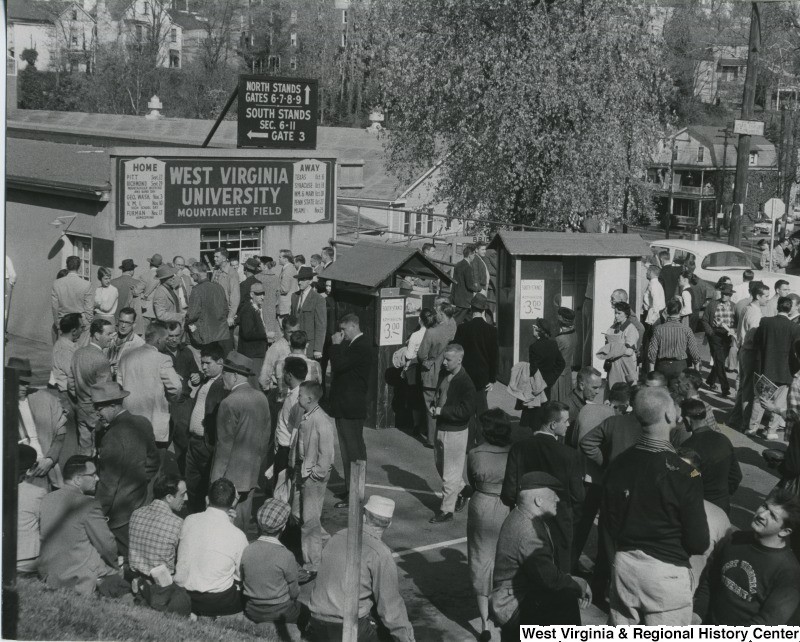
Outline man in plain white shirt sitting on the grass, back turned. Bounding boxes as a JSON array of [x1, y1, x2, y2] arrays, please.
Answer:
[[175, 477, 247, 617]]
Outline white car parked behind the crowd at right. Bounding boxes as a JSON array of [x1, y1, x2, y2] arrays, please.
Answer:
[[650, 239, 800, 294]]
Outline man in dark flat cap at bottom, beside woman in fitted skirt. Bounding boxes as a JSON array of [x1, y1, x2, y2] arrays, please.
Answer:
[[491, 471, 592, 640]]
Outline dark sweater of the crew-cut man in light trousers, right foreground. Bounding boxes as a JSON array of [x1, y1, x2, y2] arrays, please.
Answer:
[[600, 442, 709, 568]]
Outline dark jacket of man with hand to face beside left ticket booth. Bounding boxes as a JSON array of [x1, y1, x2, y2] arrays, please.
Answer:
[[328, 334, 373, 419]]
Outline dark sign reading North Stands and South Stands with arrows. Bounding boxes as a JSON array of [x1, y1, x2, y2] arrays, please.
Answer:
[[236, 75, 319, 149]]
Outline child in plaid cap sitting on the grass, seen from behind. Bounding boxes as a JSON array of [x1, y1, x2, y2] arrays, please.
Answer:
[[242, 499, 309, 631]]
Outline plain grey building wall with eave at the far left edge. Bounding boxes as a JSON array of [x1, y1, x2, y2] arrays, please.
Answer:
[[6, 189, 113, 343]]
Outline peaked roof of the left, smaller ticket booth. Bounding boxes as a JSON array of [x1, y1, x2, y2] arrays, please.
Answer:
[[321, 241, 452, 289]]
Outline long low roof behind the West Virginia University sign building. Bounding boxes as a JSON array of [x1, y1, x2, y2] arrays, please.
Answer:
[[6, 108, 408, 203]]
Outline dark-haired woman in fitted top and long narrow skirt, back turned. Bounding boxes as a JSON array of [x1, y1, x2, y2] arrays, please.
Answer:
[[467, 408, 511, 642]]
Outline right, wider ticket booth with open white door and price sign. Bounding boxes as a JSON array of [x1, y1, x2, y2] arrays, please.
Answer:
[[489, 232, 650, 383]]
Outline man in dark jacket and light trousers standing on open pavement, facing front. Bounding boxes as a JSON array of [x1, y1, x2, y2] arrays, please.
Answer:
[[428, 343, 477, 524]]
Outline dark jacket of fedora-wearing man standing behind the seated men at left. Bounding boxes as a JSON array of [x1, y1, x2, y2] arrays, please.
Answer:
[[95, 410, 160, 528]]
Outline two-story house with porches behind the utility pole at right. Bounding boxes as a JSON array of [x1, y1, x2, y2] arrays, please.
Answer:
[[647, 125, 778, 228]]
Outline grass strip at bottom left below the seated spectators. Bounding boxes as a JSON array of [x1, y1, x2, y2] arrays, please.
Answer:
[[17, 578, 299, 642]]
